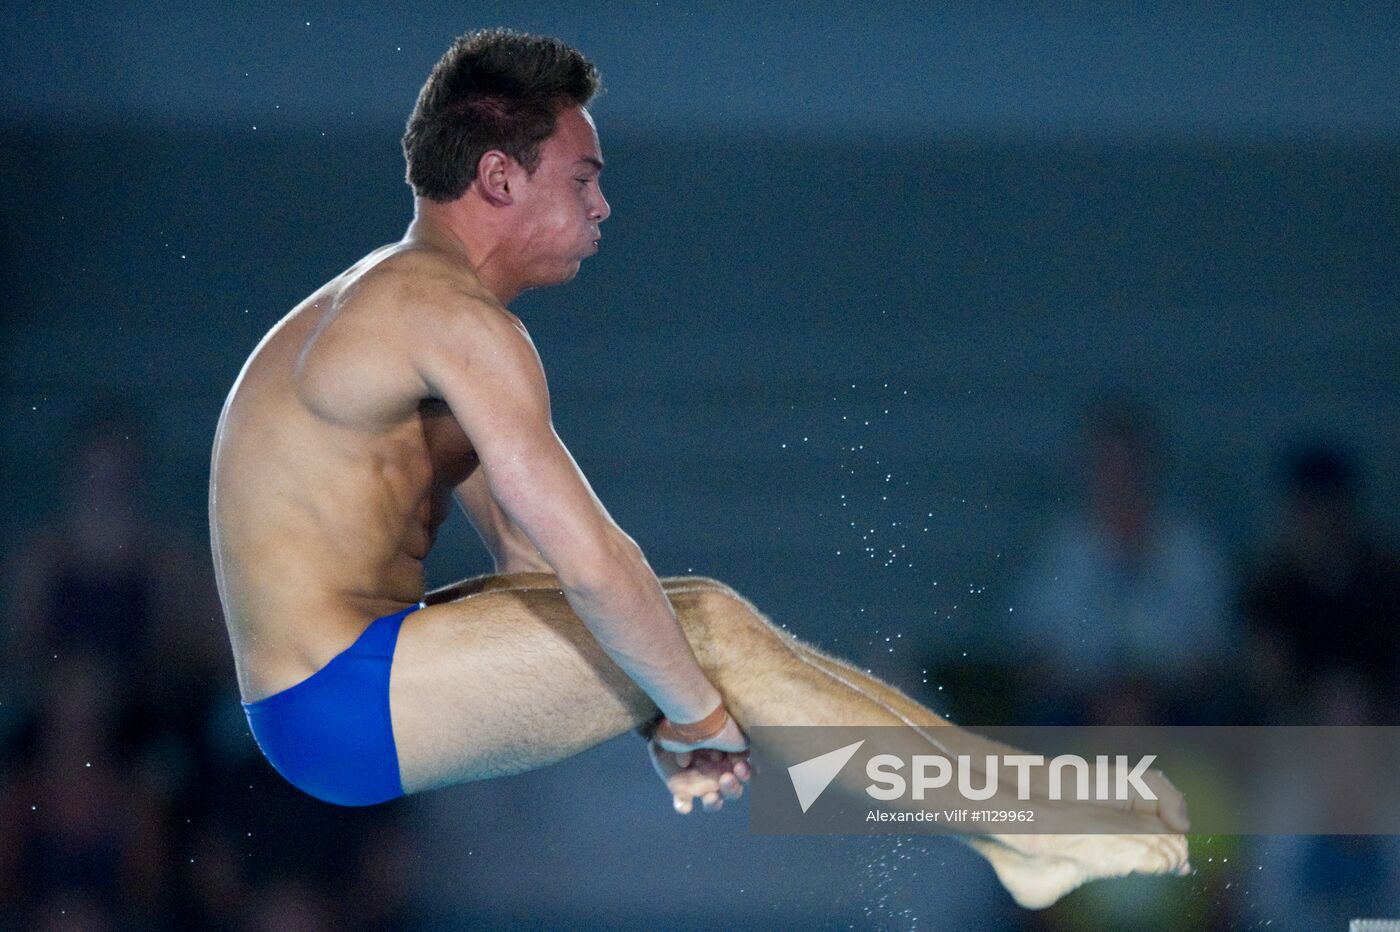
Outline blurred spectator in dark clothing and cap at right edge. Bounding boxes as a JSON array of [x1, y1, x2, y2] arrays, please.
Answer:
[[1243, 444, 1400, 723]]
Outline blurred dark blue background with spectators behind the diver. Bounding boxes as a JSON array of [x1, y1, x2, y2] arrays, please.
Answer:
[[0, 3, 1400, 929]]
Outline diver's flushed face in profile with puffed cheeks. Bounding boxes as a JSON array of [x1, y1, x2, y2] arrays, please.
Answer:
[[517, 106, 612, 284]]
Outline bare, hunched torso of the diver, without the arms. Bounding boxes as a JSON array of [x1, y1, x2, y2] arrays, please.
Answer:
[[209, 243, 495, 701]]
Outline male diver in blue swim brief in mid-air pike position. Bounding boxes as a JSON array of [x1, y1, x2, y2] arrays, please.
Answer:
[[209, 31, 1186, 905]]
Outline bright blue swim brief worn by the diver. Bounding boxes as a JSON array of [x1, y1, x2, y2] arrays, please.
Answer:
[[244, 603, 423, 806]]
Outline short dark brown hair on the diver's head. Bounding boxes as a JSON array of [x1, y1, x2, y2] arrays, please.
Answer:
[[403, 29, 599, 203]]
